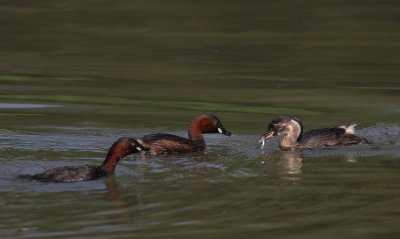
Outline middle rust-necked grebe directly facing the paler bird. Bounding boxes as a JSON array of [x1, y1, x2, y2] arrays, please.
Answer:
[[138, 114, 231, 155]]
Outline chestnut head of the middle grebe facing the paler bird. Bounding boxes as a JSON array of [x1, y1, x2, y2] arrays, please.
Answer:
[[191, 113, 232, 136]]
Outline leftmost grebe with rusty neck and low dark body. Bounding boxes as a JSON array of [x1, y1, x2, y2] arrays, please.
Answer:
[[19, 137, 144, 183]]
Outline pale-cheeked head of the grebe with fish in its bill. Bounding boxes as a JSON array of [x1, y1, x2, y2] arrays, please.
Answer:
[[259, 115, 303, 143]]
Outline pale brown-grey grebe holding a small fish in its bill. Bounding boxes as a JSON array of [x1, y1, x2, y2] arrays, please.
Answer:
[[259, 116, 368, 150]]
